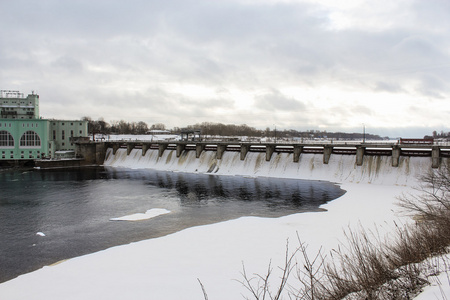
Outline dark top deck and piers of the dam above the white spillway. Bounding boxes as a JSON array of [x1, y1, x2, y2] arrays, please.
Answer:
[[88, 140, 450, 168]]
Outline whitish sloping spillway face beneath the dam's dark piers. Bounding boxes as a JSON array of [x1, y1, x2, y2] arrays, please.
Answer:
[[104, 149, 442, 185]]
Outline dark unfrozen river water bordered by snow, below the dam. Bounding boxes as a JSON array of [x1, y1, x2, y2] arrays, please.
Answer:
[[0, 167, 345, 282]]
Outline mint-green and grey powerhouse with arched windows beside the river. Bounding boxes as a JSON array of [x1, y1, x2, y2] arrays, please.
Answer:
[[0, 90, 88, 160]]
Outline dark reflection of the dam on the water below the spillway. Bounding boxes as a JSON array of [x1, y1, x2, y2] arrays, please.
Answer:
[[107, 168, 343, 211]]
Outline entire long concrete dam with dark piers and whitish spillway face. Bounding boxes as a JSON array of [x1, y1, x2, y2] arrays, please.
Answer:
[[73, 141, 450, 185]]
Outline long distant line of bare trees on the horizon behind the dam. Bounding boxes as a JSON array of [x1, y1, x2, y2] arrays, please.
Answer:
[[83, 117, 388, 140]]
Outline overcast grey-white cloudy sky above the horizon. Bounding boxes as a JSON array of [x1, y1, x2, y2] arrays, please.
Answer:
[[0, 0, 450, 137]]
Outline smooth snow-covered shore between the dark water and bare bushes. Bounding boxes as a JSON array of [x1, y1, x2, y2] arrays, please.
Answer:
[[0, 183, 426, 300]]
